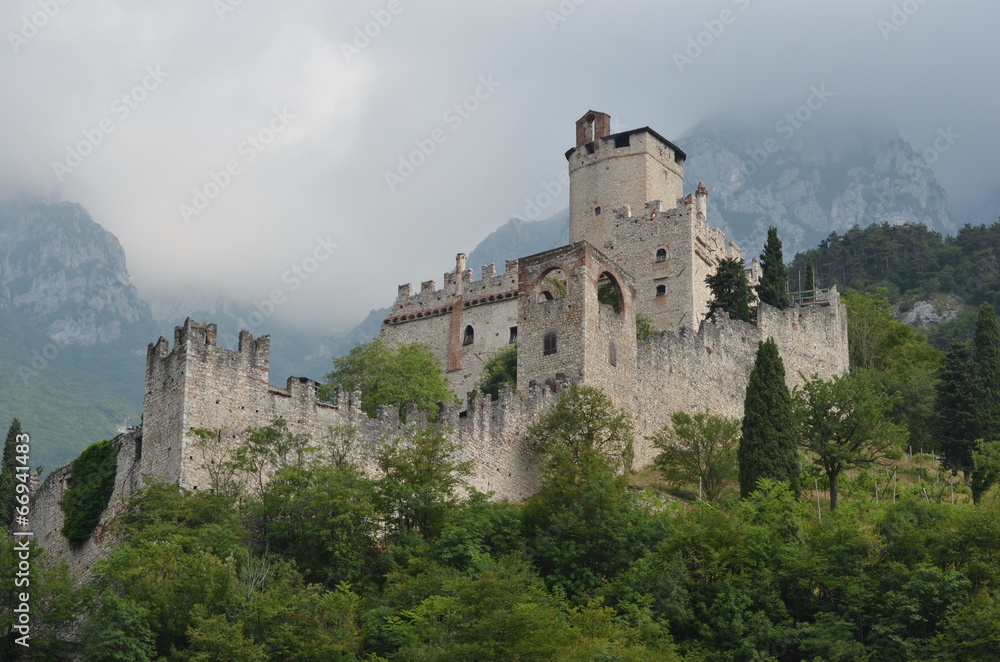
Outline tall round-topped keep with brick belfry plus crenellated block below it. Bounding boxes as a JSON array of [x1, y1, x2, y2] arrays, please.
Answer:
[[566, 111, 739, 338]]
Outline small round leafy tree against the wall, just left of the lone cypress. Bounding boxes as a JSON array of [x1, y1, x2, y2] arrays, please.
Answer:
[[650, 412, 740, 501]]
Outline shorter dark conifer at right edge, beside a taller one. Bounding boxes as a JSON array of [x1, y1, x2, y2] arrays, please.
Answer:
[[934, 342, 980, 483]]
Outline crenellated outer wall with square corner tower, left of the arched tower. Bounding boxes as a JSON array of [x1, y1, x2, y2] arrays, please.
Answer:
[[141, 319, 552, 500]]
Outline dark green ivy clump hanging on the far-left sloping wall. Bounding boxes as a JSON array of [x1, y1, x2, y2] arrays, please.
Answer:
[[62, 437, 119, 547]]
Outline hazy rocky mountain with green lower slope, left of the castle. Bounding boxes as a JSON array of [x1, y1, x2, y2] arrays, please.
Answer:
[[0, 202, 157, 469]]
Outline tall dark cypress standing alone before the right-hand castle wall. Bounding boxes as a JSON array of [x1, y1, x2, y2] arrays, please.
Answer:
[[737, 338, 799, 497]]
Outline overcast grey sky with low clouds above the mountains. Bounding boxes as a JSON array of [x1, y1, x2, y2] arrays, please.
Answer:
[[0, 0, 1000, 331]]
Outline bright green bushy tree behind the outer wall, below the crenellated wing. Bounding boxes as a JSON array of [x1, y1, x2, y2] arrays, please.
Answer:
[[320, 338, 458, 418]]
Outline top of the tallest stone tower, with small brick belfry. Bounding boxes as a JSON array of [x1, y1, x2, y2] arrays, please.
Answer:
[[566, 110, 687, 250]]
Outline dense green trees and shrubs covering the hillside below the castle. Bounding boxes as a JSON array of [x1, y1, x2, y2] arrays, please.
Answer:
[[0, 390, 1000, 662]]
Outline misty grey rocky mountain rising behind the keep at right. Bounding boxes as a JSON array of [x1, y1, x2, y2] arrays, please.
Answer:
[[678, 119, 957, 255]]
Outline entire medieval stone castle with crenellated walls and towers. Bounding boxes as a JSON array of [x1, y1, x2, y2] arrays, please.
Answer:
[[27, 111, 848, 572]]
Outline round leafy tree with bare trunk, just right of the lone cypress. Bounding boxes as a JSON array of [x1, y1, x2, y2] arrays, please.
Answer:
[[792, 371, 907, 510]]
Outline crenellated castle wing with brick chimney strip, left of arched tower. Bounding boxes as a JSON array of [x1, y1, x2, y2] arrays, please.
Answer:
[[380, 255, 518, 397]]
